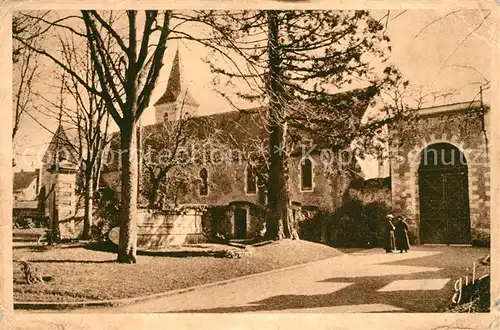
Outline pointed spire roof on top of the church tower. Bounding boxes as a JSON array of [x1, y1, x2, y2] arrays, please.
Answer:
[[155, 48, 199, 106]]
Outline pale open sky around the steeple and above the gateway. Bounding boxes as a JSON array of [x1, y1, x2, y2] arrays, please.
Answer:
[[14, 10, 498, 176]]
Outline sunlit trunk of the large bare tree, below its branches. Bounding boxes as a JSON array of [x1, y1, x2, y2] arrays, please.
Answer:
[[117, 118, 138, 263]]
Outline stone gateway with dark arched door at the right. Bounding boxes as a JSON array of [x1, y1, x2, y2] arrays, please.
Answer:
[[390, 101, 490, 244]]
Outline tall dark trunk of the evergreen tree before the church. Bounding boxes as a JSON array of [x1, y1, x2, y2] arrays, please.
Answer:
[[266, 11, 298, 239]]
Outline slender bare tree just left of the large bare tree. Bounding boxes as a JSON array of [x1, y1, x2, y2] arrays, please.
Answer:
[[32, 27, 114, 239]]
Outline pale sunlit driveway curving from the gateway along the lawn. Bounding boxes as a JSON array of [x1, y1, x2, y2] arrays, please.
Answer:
[[81, 249, 450, 313]]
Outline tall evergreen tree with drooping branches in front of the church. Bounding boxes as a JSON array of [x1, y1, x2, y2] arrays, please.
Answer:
[[189, 10, 408, 239]]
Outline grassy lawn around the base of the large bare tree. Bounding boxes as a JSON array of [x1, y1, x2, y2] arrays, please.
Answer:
[[14, 240, 343, 302]]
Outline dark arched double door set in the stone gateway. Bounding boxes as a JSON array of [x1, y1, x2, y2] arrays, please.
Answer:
[[419, 143, 470, 244]]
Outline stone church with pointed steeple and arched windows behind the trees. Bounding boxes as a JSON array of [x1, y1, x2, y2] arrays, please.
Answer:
[[102, 48, 368, 240]]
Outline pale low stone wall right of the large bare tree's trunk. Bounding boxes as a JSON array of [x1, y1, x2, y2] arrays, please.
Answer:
[[137, 210, 205, 248]]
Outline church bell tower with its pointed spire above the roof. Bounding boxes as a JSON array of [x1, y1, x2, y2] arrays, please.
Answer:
[[154, 47, 199, 123]]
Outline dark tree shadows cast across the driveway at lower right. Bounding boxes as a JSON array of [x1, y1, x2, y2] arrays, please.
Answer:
[[171, 247, 489, 313]]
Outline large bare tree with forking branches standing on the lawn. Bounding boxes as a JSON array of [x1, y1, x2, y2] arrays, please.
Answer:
[[15, 10, 171, 263]]
